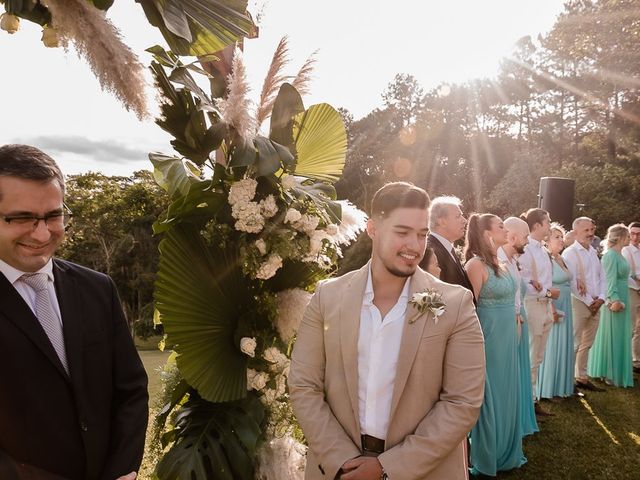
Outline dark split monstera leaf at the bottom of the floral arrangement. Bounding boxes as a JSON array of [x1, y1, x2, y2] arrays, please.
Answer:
[[156, 395, 264, 480]]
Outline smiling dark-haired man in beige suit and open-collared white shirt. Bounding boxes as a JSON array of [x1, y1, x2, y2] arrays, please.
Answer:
[[289, 182, 485, 480]]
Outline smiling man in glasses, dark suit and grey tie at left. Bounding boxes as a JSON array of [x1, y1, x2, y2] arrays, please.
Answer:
[[0, 145, 148, 480]]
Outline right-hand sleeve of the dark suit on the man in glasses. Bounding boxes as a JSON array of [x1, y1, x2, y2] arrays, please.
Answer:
[[101, 280, 149, 480]]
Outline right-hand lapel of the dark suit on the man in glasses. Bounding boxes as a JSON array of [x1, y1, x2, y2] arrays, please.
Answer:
[[53, 259, 82, 383]]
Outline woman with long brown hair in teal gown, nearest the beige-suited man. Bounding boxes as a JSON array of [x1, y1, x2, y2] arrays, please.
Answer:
[[465, 214, 527, 476]]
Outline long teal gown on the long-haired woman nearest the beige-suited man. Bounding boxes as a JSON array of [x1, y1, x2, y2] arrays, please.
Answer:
[[470, 268, 527, 476]]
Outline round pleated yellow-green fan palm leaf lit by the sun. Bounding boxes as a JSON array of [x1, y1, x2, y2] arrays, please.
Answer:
[[293, 103, 347, 182]]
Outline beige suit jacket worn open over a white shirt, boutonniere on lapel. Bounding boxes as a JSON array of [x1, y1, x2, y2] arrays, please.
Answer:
[[289, 265, 485, 480]]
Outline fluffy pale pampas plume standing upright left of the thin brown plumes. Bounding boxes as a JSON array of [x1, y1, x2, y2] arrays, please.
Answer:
[[217, 48, 255, 139]]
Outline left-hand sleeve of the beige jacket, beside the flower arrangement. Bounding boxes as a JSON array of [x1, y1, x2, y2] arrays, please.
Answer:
[[289, 285, 361, 479]]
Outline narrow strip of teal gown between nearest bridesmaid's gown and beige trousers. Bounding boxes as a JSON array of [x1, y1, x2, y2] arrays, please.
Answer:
[[518, 279, 540, 437]]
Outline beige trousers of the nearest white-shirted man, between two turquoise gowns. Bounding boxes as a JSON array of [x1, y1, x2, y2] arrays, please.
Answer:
[[524, 297, 553, 400]]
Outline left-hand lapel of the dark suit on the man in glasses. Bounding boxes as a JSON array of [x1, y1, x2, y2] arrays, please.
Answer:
[[0, 268, 69, 379]]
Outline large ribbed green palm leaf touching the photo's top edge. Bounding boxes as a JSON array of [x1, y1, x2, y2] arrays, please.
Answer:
[[136, 0, 256, 56]]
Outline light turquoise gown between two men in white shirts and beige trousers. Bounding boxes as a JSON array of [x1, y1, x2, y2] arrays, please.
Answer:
[[538, 260, 575, 398]]
